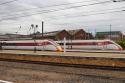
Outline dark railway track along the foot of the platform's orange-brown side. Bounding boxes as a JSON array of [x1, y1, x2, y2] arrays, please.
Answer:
[[0, 59, 125, 71]]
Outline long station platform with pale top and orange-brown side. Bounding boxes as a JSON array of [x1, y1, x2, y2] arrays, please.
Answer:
[[0, 50, 125, 68]]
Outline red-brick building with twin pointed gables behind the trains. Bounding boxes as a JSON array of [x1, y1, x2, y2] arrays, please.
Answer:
[[32, 29, 93, 40]]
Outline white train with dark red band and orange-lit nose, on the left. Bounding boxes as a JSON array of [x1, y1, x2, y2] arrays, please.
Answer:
[[0, 40, 62, 51]]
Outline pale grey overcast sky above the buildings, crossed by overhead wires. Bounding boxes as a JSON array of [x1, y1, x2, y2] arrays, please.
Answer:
[[0, 0, 125, 34]]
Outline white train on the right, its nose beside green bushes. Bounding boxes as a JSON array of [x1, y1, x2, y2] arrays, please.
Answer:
[[56, 40, 122, 50]]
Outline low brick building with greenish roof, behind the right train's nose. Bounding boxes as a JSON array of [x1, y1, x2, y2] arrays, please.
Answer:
[[96, 31, 123, 41]]
